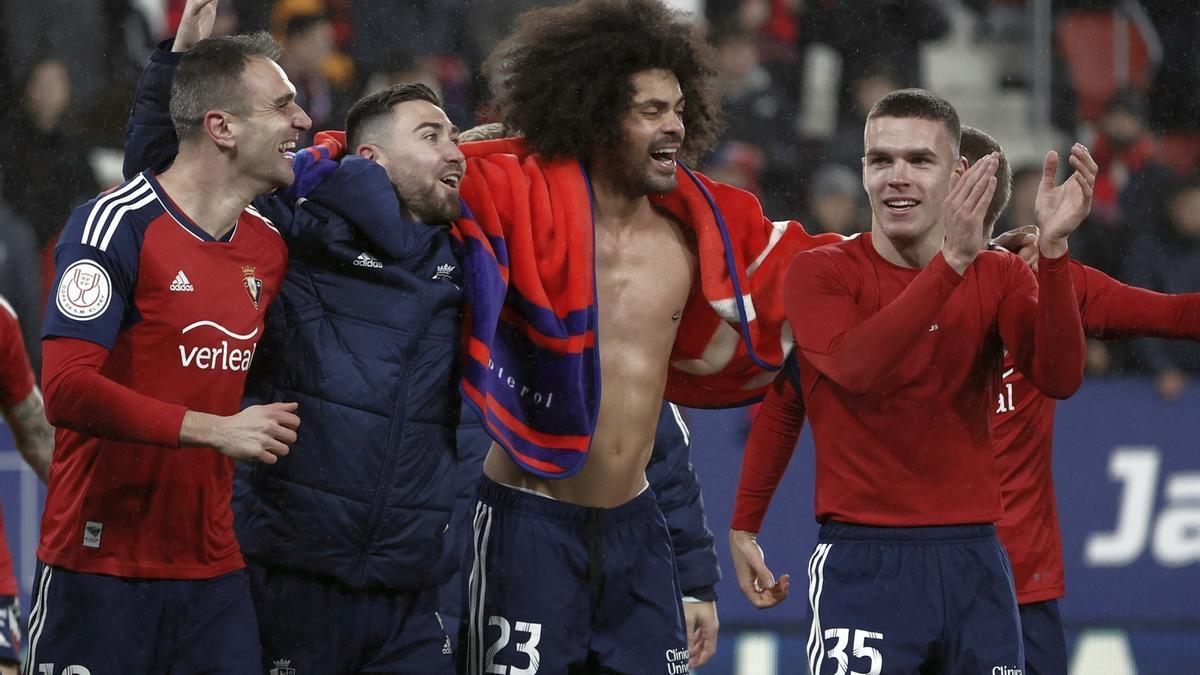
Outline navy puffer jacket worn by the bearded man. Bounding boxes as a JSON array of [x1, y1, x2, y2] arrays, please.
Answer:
[[234, 156, 462, 590]]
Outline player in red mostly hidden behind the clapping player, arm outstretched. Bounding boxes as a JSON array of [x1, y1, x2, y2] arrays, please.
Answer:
[[962, 127, 1200, 675]]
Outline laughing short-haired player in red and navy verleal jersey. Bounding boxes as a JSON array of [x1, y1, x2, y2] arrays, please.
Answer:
[[28, 30, 311, 675]]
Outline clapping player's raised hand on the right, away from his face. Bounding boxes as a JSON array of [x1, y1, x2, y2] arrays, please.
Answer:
[[1033, 143, 1099, 258]]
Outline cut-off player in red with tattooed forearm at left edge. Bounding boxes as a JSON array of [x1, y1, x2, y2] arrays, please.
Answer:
[[0, 297, 54, 675]]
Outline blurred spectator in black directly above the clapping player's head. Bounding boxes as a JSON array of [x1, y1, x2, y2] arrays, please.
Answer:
[[800, 0, 950, 126]]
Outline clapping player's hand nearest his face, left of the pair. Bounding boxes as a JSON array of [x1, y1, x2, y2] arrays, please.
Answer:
[[942, 153, 1000, 274]]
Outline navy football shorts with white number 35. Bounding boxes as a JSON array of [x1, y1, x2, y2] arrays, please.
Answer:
[[808, 522, 1024, 675]]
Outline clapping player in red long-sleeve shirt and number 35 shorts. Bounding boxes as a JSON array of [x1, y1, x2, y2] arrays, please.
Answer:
[[731, 90, 1096, 673]]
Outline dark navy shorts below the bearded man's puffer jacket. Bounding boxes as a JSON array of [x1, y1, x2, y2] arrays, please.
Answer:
[[248, 562, 454, 675]]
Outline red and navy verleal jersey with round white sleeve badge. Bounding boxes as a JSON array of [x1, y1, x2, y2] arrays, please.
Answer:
[[37, 172, 287, 579]]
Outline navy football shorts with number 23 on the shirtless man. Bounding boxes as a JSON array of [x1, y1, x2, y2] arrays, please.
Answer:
[[458, 476, 689, 675]]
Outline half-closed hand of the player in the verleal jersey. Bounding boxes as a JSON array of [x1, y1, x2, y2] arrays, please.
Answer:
[[186, 402, 300, 464]]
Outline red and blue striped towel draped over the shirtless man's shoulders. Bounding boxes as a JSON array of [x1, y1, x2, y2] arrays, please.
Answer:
[[293, 132, 841, 478]]
